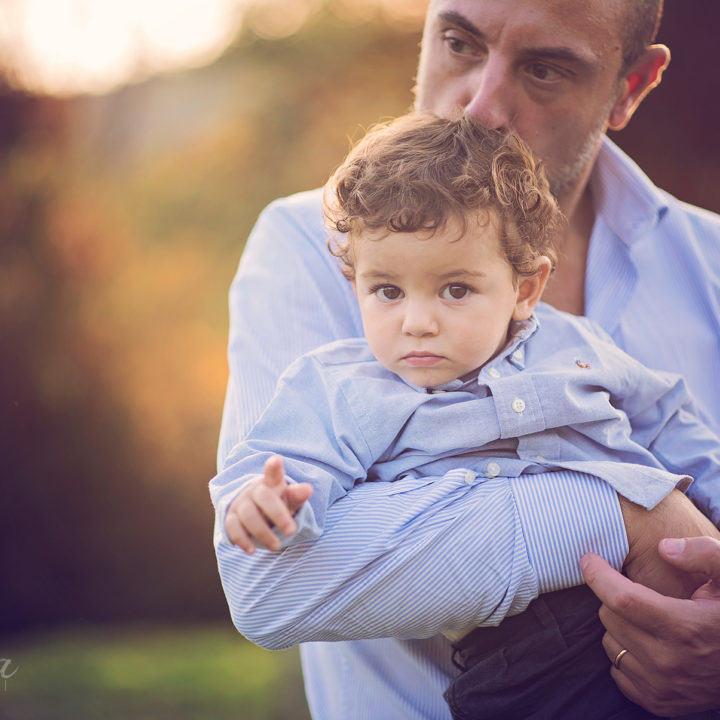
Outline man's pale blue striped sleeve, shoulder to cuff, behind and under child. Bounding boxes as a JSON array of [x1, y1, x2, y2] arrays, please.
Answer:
[[215, 196, 627, 648]]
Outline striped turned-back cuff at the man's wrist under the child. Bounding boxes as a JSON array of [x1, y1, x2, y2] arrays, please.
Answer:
[[511, 471, 628, 593]]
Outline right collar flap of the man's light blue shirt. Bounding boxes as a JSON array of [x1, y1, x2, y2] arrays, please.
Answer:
[[590, 137, 668, 245]]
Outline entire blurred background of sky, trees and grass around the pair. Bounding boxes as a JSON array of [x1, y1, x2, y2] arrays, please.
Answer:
[[0, 0, 720, 720]]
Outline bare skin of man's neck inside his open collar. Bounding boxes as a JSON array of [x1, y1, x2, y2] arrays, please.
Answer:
[[542, 176, 595, 315]]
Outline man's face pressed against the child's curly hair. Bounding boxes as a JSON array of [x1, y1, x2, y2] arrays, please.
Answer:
[[416, 0, 622, 199]]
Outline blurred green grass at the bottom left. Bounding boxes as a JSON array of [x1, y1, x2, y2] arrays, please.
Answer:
[[0, 625, 309, 720]]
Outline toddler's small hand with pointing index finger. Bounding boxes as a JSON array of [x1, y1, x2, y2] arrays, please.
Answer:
[[225, 455, 312, 555]]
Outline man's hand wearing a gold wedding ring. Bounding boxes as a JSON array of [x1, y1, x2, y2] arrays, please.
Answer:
[[581, 516, 720, 716]]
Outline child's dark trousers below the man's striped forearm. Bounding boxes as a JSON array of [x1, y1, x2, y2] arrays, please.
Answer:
[[445, 585, 717, 720]]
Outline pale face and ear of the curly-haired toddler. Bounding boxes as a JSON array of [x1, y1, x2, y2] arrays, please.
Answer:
[[353, 215, 549, 387]]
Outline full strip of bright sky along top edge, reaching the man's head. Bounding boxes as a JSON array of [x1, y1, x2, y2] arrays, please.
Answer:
[[0, 0, 426, 94]]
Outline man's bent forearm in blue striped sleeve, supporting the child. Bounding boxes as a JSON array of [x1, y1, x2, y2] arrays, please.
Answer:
[[216, 470, 625, 649]]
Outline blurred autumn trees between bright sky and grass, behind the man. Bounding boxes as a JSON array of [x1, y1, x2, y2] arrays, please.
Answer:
[[0, 0, 720, 631]]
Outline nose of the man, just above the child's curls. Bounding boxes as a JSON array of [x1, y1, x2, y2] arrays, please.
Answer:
[[463, 56, 516, 133]]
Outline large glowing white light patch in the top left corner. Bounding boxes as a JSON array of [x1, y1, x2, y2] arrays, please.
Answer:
[[0, 0, 245, 93]]
